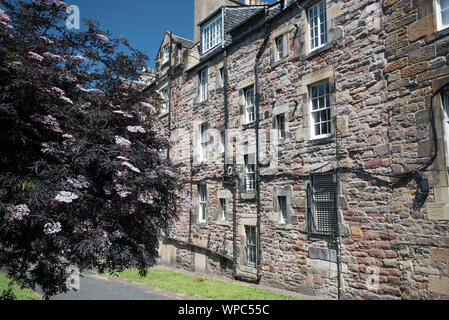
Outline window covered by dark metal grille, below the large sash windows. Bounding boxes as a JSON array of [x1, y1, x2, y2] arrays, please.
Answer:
[[308, 175, 338, 236]]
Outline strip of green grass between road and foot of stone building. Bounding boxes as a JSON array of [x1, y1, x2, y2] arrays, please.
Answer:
[[118, 270, 301, 300]]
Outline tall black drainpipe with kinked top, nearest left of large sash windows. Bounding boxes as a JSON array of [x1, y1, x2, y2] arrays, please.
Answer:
[[254, 7, 270, 282]]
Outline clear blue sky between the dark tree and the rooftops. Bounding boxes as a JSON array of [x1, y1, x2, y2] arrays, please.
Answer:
[[65, 0, 276, 68]]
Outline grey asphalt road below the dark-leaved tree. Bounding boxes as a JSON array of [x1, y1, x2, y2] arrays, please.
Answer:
[[39, 272, 203, 300]]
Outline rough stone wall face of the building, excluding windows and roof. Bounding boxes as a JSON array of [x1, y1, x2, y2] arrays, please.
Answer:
[[154, 0, 449, 299]]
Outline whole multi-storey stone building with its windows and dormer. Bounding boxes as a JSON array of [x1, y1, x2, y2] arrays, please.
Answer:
[[146, 0, 449, 299]]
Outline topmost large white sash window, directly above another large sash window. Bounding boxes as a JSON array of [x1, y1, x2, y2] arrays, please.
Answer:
[[308, 0, 327, 51]]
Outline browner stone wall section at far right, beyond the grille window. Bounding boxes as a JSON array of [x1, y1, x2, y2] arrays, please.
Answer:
[[383, 0, 449, 299]]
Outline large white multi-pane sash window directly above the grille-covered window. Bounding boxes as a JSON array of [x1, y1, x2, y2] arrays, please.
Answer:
[[309, 81, 332, 140]]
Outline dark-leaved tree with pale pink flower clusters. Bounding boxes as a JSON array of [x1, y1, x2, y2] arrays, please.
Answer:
[[0, 0, 186, 297]]
